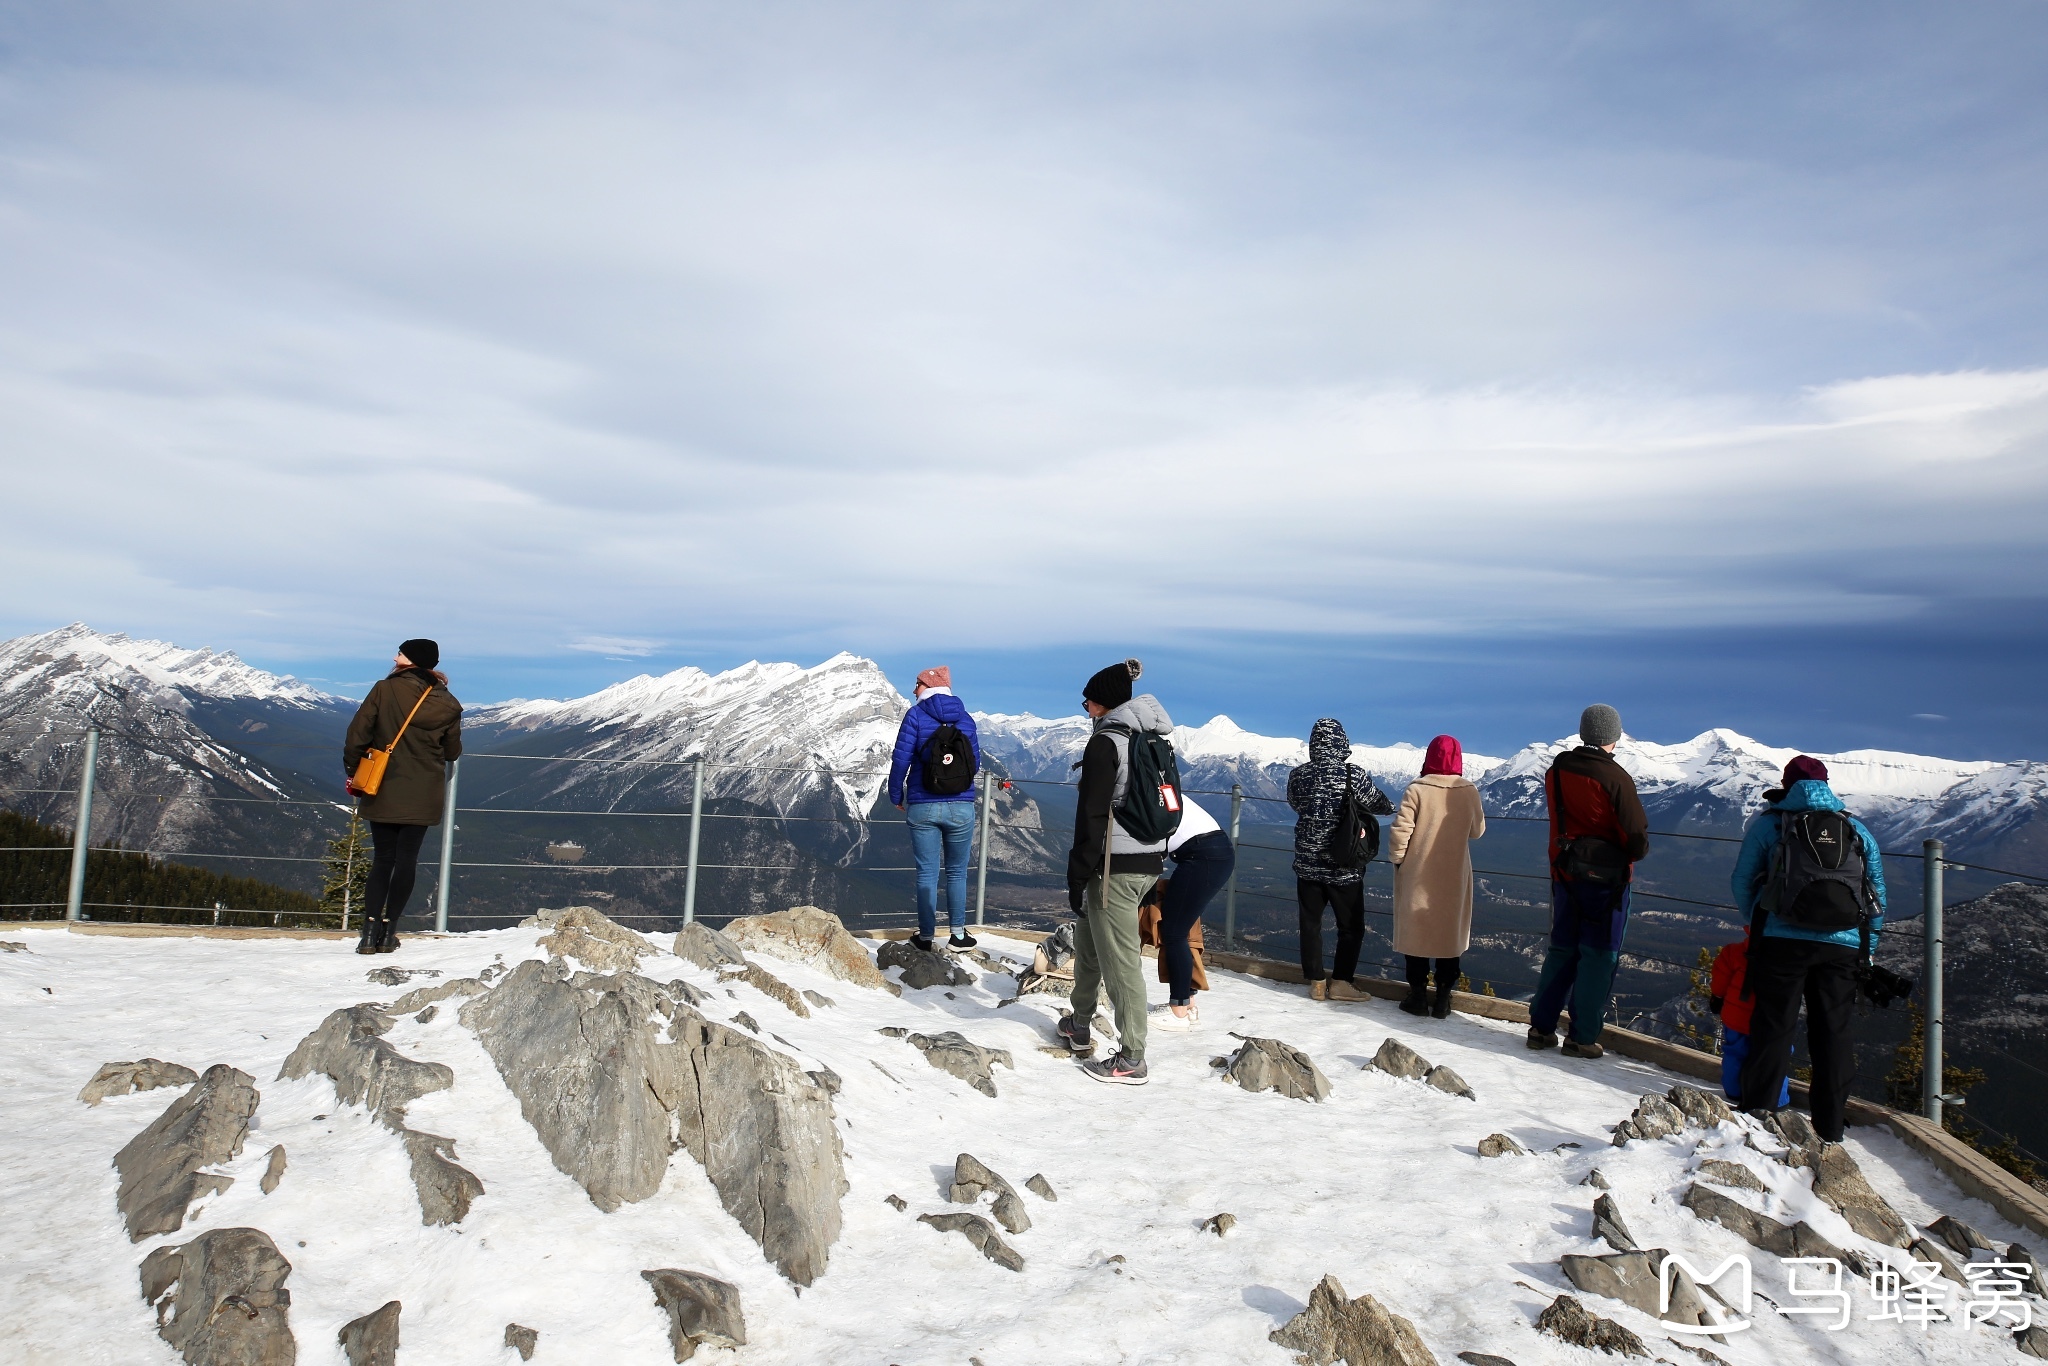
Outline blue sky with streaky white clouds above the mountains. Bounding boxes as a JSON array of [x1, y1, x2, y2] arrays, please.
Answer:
[[0, 0, 2048, 758]]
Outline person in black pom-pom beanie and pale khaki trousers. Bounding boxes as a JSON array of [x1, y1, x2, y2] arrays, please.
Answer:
[[1059, 659, 1174, 1085]]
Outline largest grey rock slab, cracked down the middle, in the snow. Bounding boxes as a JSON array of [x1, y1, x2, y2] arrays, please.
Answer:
[[463, 961, 847, 1284]]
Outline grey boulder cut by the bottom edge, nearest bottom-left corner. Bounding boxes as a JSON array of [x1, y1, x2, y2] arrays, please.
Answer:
[[141, 1229, 299, 1366]]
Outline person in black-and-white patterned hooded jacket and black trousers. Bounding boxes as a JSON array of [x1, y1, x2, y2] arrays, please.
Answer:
[[1286, 717, 1395, 1001]]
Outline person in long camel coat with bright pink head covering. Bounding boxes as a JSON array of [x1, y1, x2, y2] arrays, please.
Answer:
[[1386, 735, 1487, 1020]]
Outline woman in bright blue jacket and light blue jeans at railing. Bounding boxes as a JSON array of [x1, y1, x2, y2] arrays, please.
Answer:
[[889, 664, 981, 950]]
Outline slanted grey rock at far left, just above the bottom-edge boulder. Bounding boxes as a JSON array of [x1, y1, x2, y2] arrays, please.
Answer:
[[115, 1063, 262, 1243]]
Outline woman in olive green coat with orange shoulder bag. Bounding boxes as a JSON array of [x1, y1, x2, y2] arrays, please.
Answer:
[[342, 639, 463, 954]]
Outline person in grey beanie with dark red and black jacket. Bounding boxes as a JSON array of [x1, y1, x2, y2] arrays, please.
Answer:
[[1528, 702, 1651, 1057]]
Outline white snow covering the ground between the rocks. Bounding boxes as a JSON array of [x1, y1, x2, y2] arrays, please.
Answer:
[[0, 928, 2038, 1366]]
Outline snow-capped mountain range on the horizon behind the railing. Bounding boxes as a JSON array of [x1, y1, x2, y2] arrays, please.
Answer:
[[12, 625, 2048, 872]]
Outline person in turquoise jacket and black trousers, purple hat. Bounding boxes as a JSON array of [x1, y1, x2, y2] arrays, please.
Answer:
[[1729, 754, 1884, 1143]]
